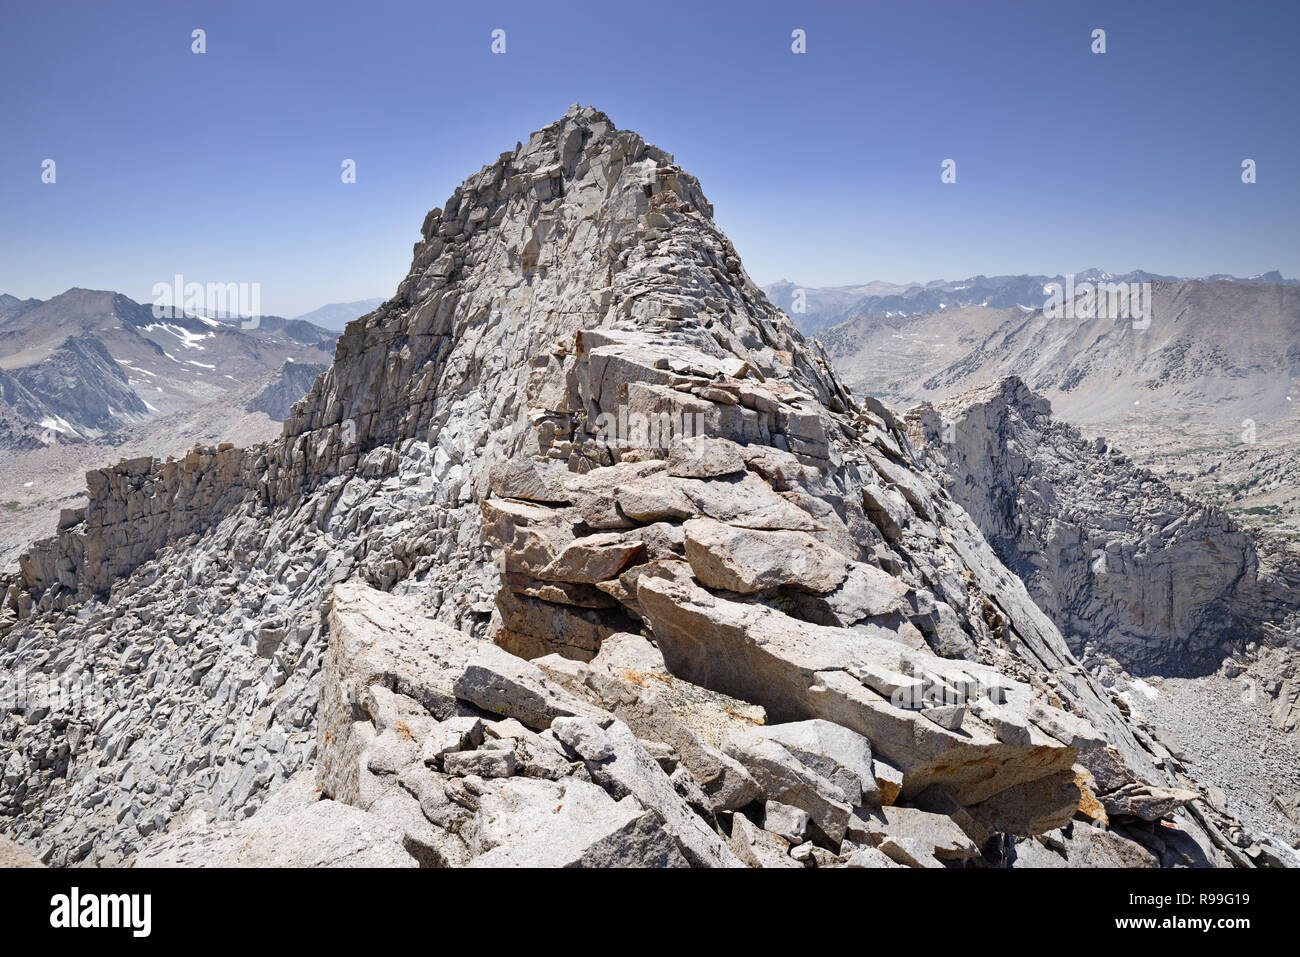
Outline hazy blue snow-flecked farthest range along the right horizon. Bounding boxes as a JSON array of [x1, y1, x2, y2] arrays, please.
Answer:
[[763, 269, 1300, 335]]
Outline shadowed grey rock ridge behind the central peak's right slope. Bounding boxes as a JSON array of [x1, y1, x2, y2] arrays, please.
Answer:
[[907, 377, 1295, 675]]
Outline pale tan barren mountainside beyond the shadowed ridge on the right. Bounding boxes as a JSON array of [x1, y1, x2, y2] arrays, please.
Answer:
[[816, 277, 1300, 428]]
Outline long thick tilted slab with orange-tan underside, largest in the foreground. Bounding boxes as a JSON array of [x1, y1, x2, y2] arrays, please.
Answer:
[[637, 577, 1078, 805]]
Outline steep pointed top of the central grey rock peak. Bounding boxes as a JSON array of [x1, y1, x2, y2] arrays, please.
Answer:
[[274, 108, 842, 493]]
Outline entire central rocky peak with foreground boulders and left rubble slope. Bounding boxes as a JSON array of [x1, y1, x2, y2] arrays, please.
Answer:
[[0, 107, 1275, 867]]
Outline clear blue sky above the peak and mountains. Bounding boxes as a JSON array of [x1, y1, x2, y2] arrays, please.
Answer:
[[0, 0, 1300, 315]]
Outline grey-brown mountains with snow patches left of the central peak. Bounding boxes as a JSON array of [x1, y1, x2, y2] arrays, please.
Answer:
[[0, 289, 337, 449]]
